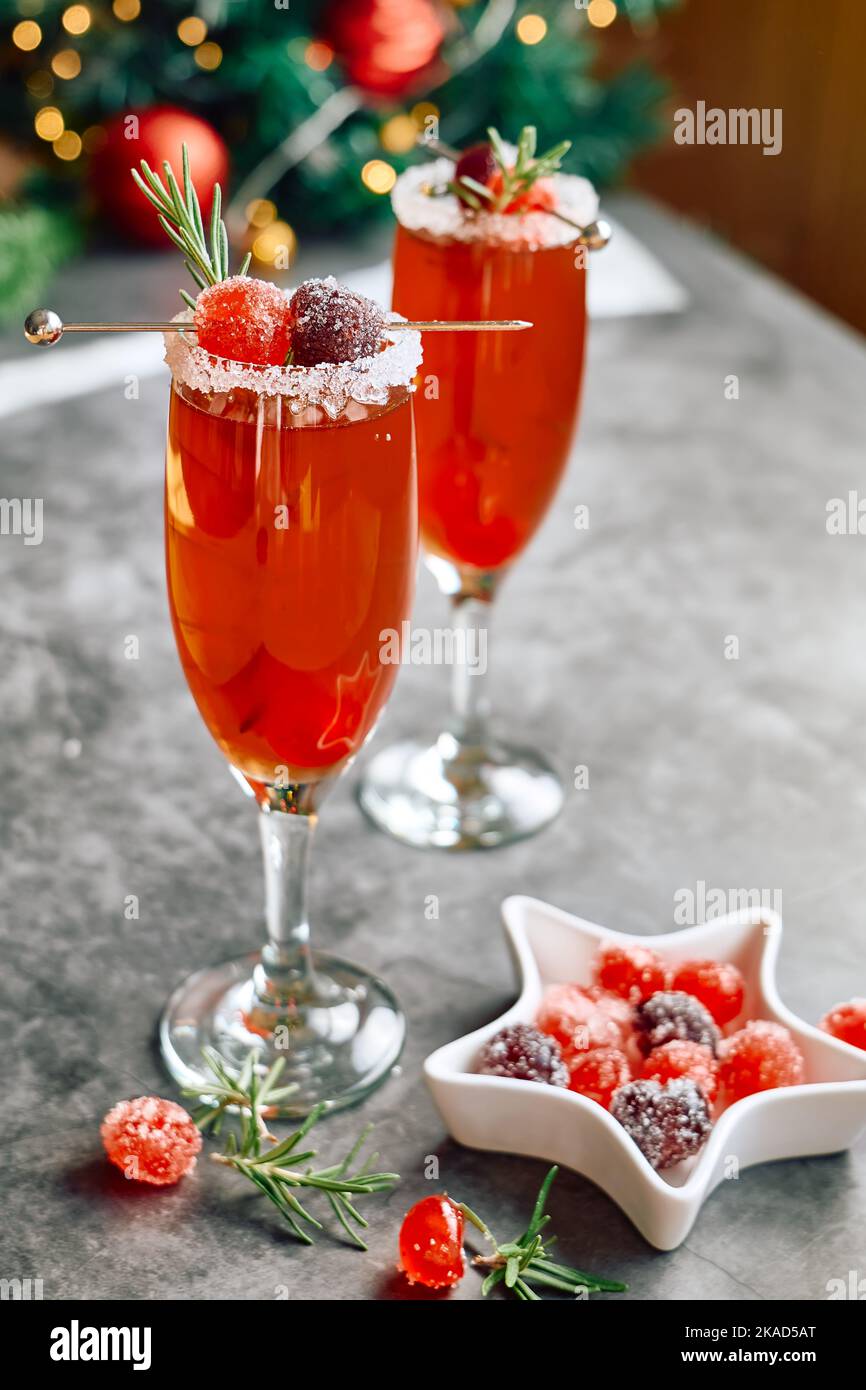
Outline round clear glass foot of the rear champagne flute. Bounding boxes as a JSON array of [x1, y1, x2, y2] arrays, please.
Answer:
[[359, 734, 564, 849]]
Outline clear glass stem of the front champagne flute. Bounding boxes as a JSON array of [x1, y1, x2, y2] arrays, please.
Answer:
[[256, 799, 317, 1005]]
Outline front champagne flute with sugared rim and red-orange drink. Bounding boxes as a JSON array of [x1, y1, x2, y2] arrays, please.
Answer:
[[160, 319, 420, 1115]]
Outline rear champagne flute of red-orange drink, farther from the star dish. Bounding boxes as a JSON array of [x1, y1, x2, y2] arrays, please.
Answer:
[[360, 161, 598, 849]]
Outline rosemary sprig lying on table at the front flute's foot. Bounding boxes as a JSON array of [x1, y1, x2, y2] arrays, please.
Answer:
[[213, 1093, 399, 1250]]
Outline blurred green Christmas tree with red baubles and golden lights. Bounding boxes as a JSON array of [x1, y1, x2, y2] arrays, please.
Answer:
[[0, 0, 677, 314]]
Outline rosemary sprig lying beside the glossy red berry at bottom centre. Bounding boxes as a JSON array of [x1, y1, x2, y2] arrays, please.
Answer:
[[460, 1168, 628, 1302]]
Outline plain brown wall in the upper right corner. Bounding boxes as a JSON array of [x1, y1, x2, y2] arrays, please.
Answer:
[[617, 0, 866, 332]]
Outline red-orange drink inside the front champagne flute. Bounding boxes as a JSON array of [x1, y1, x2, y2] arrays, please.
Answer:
[[165, 381, 417, 784]]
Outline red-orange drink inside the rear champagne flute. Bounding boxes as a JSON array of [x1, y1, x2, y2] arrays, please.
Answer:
[[393, 218, 587, 570]]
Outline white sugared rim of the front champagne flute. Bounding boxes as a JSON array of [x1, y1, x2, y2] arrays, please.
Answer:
[[164, 309, 423, 420]]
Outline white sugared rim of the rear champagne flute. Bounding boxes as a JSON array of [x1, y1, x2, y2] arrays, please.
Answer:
[[391, 160, 599, 250]]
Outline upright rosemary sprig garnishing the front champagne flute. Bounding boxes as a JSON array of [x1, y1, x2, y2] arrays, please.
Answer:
[[129, 145, 252, 309]]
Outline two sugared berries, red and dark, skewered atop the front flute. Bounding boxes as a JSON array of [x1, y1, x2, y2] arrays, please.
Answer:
[[193, 275, 385, 367]]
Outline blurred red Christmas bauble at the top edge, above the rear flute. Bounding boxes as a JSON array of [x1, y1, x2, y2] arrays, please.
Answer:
[[325, 0, 445, 97]]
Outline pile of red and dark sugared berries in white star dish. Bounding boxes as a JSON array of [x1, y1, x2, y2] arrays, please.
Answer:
[[478, 942, 822, 1169]]
